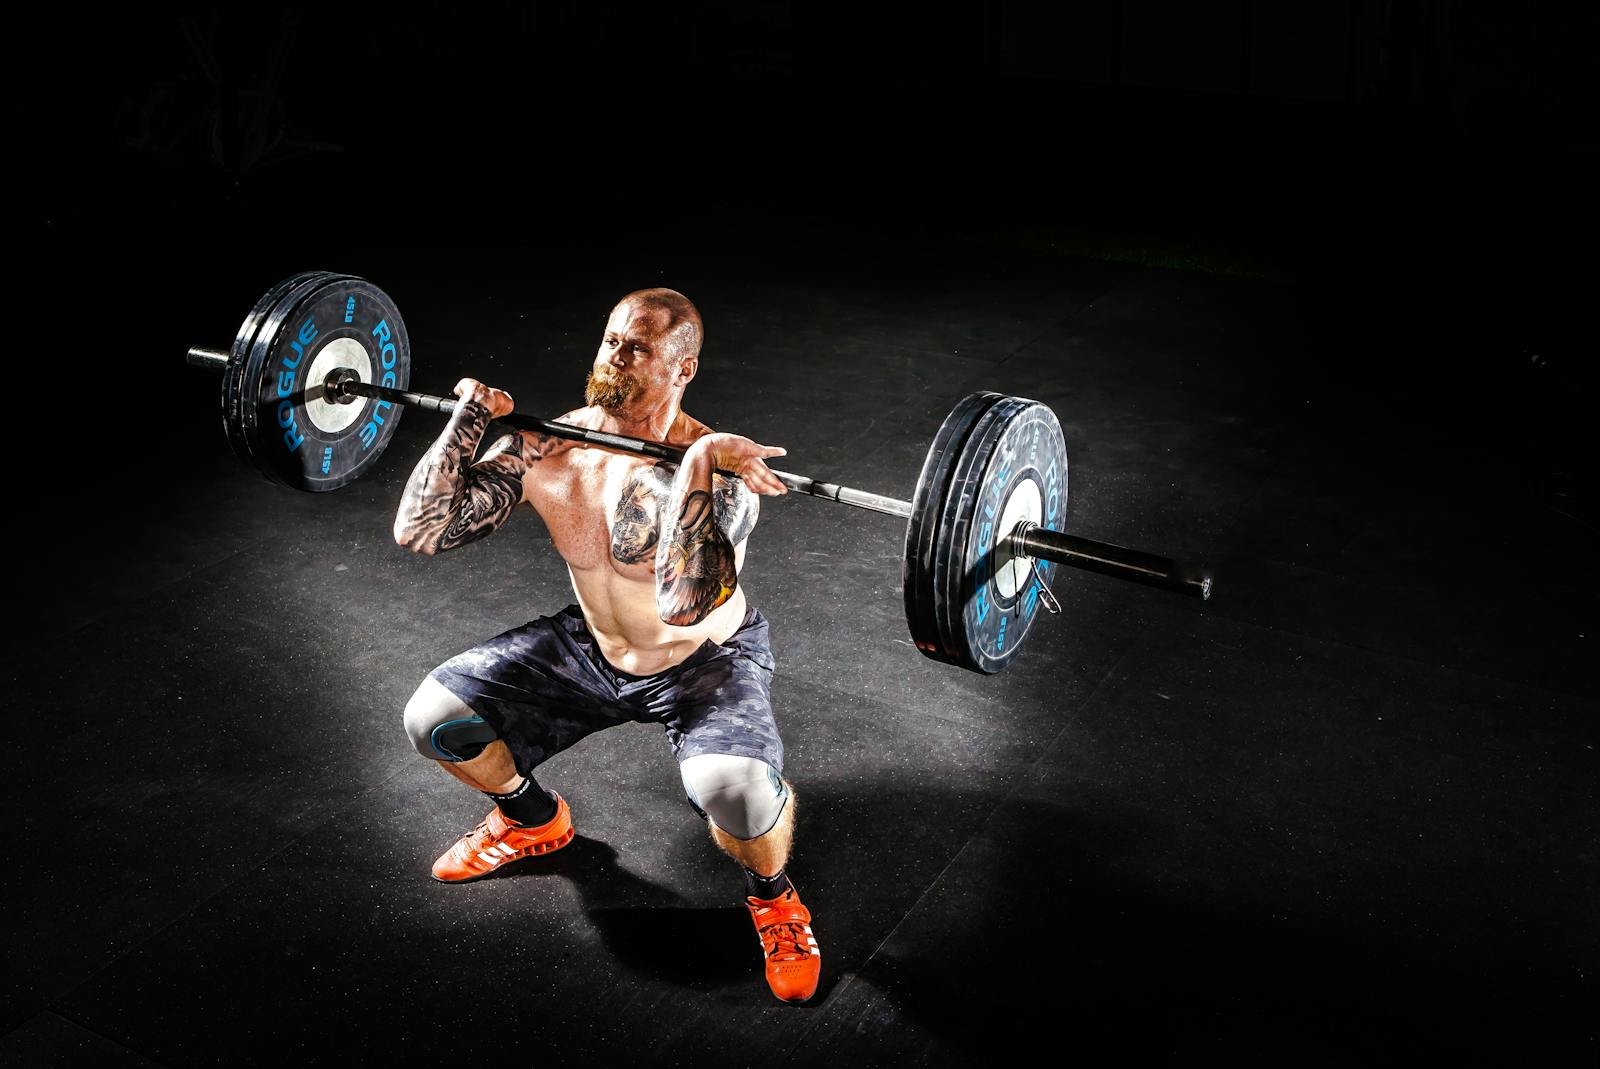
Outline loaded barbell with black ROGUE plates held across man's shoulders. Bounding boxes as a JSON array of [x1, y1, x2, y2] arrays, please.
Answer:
[[189, 270, 1211, 672]]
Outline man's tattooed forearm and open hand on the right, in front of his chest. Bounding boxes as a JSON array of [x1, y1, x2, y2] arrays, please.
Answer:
[[656, 434, 787, 627]]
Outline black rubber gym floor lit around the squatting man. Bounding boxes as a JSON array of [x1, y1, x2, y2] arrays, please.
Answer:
[[0, 202, 1600, 1066]]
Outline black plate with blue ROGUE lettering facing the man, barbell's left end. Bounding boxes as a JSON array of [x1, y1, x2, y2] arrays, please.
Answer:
[[238, 275, 411, 493]]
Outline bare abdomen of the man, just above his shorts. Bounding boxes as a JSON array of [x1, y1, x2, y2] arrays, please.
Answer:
[[566, 562, 746, 675]]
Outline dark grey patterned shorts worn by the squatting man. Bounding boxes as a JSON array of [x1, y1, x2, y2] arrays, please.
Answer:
[[429, 605, 784, 776]]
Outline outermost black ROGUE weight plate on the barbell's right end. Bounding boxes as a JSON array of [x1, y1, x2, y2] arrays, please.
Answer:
[[936, 397, 1067, 674]]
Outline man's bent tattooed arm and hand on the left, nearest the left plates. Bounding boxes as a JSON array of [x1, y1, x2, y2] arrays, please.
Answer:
[[394, 379, 549, 555]]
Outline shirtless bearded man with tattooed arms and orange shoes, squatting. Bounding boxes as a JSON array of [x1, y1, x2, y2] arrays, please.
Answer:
[[395, 290, 821, 1002]]
